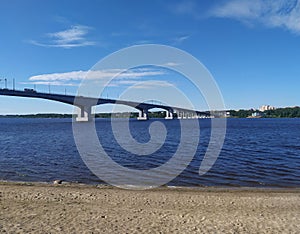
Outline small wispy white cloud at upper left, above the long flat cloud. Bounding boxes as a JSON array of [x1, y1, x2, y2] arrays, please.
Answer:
[[29, 25, 96, 48]]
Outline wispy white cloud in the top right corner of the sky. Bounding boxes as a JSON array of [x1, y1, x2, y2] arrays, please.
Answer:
[[210, 0, 300, 33]]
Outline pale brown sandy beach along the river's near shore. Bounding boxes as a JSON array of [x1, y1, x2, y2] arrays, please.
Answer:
[[0, 182, 300, 233]]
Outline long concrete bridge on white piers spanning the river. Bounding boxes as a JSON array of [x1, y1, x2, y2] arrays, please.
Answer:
[[0, 88, 210, 121]]
